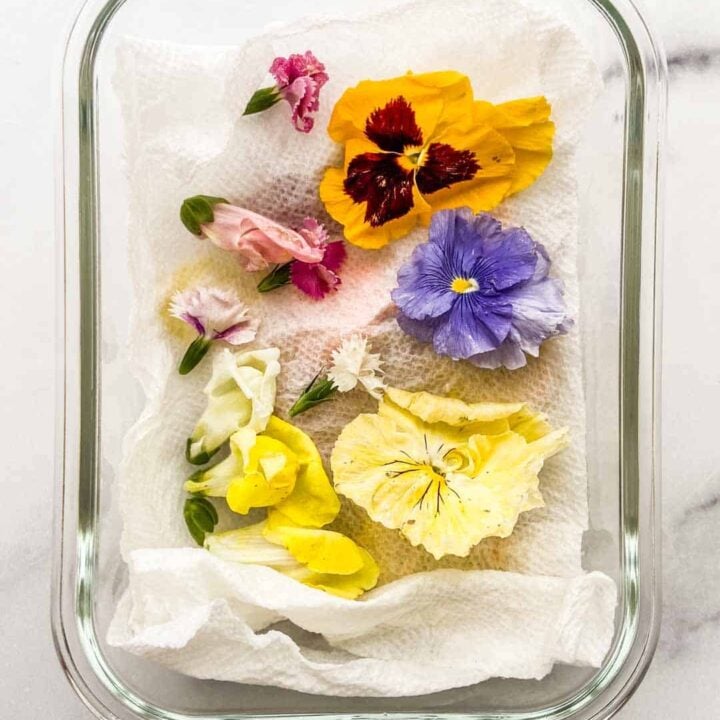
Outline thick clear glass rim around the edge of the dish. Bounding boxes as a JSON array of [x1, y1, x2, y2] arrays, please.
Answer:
[[52, 0, 667, 720]]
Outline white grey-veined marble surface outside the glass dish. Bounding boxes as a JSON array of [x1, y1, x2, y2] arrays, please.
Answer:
[[0, 0, 720, 720]]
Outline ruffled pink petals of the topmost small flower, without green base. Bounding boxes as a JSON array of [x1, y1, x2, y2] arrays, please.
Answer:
[[270, 50, 329, 133]]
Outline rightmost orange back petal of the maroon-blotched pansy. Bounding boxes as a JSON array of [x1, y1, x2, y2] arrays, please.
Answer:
[[475, 96, 555, 194]]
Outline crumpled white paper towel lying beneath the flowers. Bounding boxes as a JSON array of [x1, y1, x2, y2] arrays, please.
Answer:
[[108, 0, 615, 696]]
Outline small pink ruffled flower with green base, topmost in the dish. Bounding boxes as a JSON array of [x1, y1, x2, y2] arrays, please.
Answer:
[[243, 50, 329, 133]]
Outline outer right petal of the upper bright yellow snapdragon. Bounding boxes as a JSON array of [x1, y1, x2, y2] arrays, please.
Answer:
[[265, 416, 340, 528]]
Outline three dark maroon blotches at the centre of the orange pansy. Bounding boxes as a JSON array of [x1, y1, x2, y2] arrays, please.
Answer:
[[344, 95, 480, 227]]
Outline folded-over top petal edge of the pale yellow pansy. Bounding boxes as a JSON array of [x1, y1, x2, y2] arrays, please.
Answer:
[[385, 387, 525, 427]]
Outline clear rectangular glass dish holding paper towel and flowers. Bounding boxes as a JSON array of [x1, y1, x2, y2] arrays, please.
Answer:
[[53, 0, 665, 720]]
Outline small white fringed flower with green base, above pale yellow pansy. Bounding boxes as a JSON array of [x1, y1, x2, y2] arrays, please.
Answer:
[[290, 335, 385, 417]]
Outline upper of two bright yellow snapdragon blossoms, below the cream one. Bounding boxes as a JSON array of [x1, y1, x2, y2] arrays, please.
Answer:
[[185, 416, 340, 527]]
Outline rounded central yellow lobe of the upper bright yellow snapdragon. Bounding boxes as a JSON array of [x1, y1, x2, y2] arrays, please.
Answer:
[[226, 435, 299, 515]]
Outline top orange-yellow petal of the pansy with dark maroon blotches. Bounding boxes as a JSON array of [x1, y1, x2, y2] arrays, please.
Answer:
[[328, 71, 472, 143]]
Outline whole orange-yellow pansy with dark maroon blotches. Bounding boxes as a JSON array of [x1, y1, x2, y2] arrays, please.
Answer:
[[320, 71, 555, 248]]
